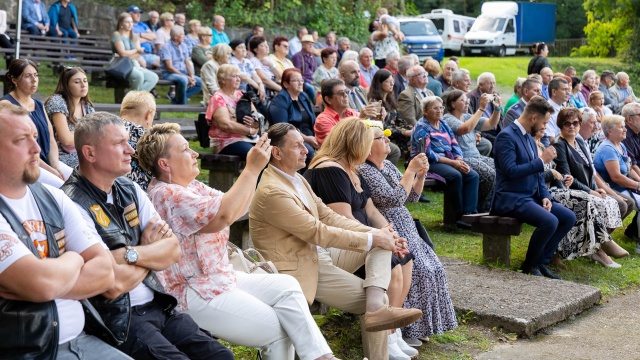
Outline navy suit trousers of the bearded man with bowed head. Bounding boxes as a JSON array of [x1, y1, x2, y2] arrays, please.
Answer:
[[510, 199, 576, 266]]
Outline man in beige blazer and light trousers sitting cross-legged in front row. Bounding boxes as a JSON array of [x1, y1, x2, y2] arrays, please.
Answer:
[[249, 123, 422, 360]]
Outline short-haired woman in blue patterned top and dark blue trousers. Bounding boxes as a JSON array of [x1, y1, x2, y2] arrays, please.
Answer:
[[411, 96, 480, 228]]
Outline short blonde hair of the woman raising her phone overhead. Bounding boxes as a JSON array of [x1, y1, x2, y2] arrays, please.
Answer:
[[137, 123, 180, 177]]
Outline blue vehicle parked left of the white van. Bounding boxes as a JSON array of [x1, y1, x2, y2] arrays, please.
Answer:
[[398, 17, 444, 61]]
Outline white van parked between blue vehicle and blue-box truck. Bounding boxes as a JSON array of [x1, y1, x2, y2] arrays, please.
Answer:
[[419, 9, 476, 55]]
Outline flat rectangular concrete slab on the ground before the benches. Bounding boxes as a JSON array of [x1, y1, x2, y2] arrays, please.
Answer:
[[440, 257, 602, 337]]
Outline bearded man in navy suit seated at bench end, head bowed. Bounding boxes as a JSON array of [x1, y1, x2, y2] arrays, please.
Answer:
[[491, 96, 576, 279]]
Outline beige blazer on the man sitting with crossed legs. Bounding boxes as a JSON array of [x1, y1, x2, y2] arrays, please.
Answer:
[[249, 166, 371, 304]]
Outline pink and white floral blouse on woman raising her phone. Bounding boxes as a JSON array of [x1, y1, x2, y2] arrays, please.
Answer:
[[147, 178, 236, 311]]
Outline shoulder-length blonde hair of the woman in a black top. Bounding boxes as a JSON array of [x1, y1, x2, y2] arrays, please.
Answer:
[[309, 117, 373, 171]]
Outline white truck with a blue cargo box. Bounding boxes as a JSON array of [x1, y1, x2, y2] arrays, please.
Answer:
[[461, 1, 556, 56]]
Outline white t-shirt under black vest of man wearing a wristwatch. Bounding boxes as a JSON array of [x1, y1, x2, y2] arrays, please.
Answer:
[[76, 183, 158, 306]]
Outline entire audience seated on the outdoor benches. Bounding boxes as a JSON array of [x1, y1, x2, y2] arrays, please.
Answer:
[[0, 0, 640, 360]]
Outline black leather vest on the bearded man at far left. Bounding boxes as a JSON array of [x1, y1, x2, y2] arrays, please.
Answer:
[[0, 183, 113, 360]]
